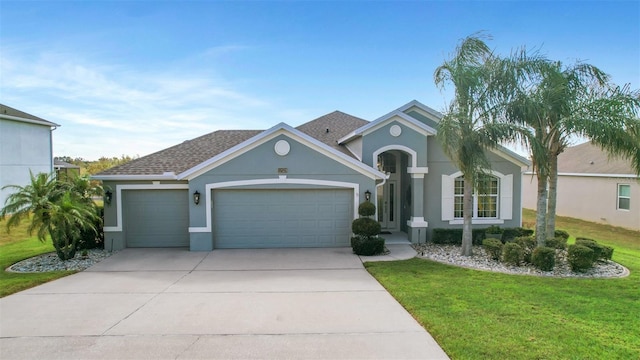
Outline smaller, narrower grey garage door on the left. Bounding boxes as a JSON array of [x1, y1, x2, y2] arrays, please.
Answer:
[[123, 190, 189, 247]]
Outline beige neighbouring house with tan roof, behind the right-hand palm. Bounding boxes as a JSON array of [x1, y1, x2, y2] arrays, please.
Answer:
[[522, 142, 640, 230]]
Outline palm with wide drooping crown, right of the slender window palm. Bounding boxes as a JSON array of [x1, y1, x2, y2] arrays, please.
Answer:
[[506, 55, 640, 246]]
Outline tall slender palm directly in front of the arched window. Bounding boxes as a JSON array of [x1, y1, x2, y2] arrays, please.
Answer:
[[434, 34, 516, 256]]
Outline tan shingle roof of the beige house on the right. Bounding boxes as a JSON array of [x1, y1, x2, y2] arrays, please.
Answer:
[[558, 142, 634, 174]]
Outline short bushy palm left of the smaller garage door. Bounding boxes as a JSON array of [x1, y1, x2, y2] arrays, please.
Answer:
[[0, 173, 97, 260]]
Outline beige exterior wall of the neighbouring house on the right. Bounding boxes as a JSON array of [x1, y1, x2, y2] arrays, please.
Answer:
[[522, 174, 640, 230]]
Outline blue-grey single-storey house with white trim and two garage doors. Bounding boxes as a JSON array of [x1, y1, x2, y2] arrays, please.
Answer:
[[93, 101, 529, 250]]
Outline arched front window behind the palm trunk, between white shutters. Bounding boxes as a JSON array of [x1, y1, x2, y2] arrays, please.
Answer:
[[453, 175, 498, 219]]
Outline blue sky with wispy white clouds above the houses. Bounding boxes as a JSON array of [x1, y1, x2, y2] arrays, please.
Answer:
[[0, 0, 640, 160]]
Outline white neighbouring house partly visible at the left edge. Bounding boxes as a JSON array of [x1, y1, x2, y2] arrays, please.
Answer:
[[0, 104, 60, 208]]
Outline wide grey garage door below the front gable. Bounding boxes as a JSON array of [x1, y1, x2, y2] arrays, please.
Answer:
[[213, 189, 353, 248]]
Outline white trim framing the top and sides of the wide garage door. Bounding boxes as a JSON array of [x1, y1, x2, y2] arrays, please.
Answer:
[[189, 175, 360, 233]]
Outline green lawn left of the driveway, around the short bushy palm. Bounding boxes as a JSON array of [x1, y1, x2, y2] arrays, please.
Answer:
[[0, 221, 75, 297]]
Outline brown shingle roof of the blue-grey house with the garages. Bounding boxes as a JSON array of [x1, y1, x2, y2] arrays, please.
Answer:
[[92, 111, 367, 175]]
